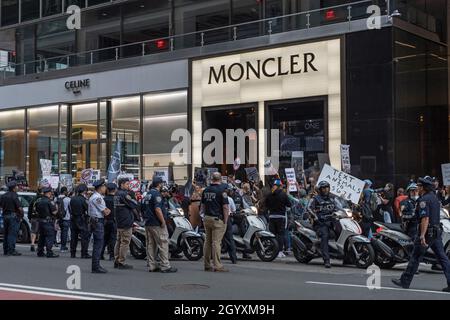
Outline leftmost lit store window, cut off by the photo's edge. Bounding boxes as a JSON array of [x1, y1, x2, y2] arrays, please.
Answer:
[[0, 110, 25, 184]]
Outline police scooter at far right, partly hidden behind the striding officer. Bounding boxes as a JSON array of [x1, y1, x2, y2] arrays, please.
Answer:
[[373, 208, 450, 269]]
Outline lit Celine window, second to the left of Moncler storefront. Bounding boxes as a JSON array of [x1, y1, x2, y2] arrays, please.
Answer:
[[111, 96, 141, 178]]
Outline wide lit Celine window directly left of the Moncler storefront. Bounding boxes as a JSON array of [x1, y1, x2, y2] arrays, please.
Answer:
[[142, 90, 188, 183]]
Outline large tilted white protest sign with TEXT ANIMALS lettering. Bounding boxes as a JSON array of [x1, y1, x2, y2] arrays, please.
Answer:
[[317, 164, 364, 204]]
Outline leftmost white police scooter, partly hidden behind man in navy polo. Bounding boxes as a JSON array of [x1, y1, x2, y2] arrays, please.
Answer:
[[130, 200, 203, 261]]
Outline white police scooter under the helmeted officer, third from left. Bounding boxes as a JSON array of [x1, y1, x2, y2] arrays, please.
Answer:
[[292, 201, 375, 269]]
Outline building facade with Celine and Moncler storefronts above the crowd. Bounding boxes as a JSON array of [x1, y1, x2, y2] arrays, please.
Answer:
[[0, 0, 449, 188]]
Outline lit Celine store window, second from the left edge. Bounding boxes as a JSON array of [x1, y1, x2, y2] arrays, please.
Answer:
[[27, 105, 59, 190]]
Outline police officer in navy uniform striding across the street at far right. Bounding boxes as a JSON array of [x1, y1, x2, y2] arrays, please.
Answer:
[[392, 177, 450, 292]]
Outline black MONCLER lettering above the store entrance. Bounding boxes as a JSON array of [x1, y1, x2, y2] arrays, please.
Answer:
[[208, 52, 319, 84]]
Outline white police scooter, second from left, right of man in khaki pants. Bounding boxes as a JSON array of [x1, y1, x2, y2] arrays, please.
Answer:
[[222, 206, 279, 262]]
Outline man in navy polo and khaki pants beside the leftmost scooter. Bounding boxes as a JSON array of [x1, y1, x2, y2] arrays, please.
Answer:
[[142, 177, 177, 273]]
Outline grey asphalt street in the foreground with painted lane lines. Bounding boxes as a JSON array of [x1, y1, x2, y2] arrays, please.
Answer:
[[0, 245, 450, 300]]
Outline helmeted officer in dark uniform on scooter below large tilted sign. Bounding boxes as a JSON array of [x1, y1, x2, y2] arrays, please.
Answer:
[[308, 181, 336, 268]]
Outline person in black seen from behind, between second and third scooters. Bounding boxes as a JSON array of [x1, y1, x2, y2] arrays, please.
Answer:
[[266, 179, 291, 258]]
